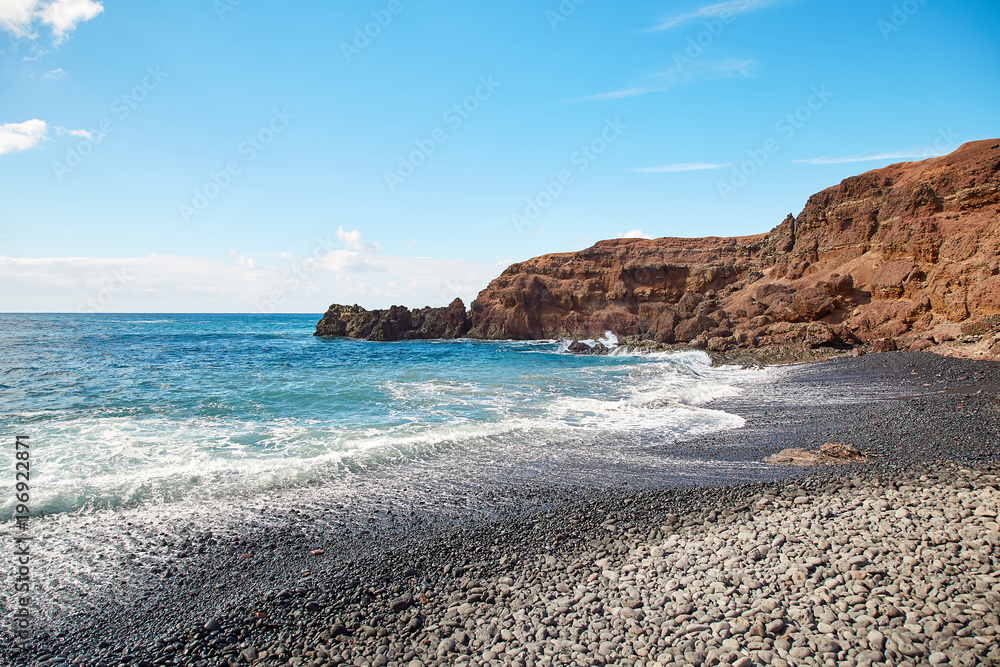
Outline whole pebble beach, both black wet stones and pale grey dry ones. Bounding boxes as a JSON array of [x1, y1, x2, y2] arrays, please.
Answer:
[[11, 353, 1000, 665]]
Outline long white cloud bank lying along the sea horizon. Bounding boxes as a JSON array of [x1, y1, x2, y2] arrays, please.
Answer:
[[0, 252, 509, 313]]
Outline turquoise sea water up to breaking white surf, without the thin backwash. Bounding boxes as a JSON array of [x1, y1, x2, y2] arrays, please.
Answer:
[[0, 314, 743, 521]]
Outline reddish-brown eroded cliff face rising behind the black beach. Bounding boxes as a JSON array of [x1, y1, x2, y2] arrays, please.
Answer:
[[469, 140, 1000, 354]]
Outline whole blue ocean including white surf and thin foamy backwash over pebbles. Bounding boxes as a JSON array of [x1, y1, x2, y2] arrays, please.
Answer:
[[0, 314, 820, 627]]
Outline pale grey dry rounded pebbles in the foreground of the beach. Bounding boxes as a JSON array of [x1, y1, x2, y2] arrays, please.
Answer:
[[362, 465, 1000, 667]]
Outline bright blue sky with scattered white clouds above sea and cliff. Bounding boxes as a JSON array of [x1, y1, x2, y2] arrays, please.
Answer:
[[0, 0, 1000, 313]]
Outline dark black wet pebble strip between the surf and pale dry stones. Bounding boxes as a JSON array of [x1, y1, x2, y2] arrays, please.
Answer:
[[3, 353, 1000, 666]]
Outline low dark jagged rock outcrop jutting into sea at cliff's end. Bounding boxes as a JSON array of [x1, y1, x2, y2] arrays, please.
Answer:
[[315, 299, 472, 341]]
